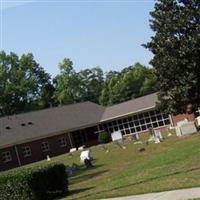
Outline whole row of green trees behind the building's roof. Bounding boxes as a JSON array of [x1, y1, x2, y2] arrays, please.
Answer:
[[0, 51, 157, 116]]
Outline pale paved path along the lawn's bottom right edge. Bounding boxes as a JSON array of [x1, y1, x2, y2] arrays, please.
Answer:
[[106, 187, 200, 200]]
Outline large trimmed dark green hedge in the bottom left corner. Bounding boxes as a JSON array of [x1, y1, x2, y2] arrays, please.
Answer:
[[0, 164, 68, 200]]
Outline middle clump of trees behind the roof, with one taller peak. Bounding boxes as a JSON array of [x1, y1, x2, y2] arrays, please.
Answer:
[[54, 58, 103, 104]]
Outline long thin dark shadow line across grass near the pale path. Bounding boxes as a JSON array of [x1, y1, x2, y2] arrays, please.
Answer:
[[72, 167, 200, 199]]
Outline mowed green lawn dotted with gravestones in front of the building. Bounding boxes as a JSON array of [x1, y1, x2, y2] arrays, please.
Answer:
[[17, 134, 200, 200]]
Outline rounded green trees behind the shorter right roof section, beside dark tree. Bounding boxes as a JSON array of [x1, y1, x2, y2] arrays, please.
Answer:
[[100, 63, 157, 105]]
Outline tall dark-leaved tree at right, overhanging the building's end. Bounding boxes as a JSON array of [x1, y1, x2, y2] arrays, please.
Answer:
[[144, 0, 200, 113]]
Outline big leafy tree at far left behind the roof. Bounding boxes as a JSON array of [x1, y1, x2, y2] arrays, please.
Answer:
[[0, 51, 50, 115]]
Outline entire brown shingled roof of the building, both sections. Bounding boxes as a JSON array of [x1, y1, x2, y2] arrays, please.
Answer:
[[0, 93, 157, 148]]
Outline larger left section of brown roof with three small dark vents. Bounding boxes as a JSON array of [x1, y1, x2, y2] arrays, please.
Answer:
[[0, 102, 105, 147]]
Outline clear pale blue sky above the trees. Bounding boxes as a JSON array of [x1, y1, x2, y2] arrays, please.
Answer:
[[0, 0, 154, 76]]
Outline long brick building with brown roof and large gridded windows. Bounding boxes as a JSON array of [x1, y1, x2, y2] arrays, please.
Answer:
[[0, 93, 194, 170]]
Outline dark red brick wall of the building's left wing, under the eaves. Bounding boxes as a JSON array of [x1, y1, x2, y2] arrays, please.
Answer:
[[0, 126, 98, 171]]
